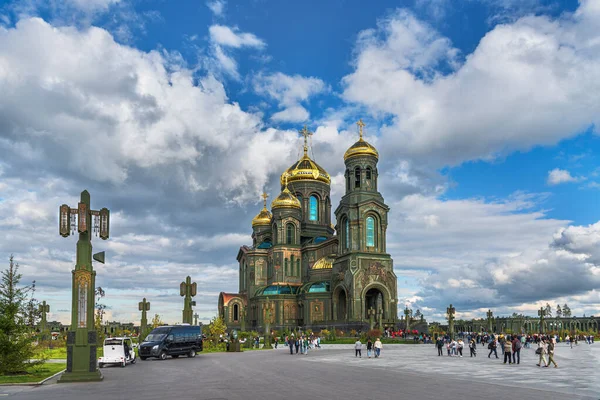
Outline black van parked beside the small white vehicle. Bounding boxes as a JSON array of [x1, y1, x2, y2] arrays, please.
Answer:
[[138, 325, 203, 360]]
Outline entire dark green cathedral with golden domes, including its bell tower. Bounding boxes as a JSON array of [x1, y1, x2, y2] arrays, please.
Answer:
[[218, 121, 398, 332]]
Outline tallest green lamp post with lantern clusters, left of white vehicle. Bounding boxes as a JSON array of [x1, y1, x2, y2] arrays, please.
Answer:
[[58, 190, 110, 383]]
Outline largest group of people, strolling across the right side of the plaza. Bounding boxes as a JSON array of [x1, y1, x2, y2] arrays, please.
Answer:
[[436, 335, 558, 368]]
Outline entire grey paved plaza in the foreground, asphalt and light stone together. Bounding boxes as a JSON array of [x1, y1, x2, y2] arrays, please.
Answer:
[[0, 344, 600, 400]]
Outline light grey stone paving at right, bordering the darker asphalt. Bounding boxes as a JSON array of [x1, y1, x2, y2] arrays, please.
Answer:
[[307, 343, 600, 399]]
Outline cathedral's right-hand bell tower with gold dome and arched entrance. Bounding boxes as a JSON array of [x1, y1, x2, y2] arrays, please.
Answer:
[[332, 120, 398, 329]]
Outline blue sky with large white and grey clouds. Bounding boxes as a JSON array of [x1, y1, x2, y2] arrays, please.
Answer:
[[0, 0, 600, 321]]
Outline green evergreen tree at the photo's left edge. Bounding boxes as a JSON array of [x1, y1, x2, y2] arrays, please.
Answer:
[[0, 255, 43, 375]]
